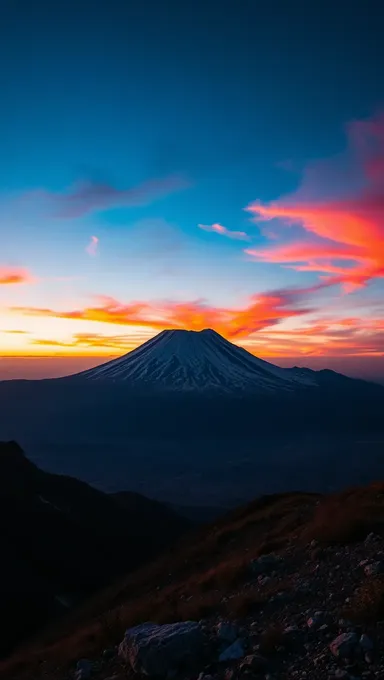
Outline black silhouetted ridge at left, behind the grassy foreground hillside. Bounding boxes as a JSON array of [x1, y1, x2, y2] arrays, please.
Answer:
[[0, 442, 190, 655]]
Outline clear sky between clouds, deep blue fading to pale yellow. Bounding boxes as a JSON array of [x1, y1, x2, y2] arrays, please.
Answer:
[[0, 0, 384, 378]]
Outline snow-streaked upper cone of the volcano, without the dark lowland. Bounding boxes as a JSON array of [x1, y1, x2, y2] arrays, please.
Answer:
[[74, 329, 317, 392]]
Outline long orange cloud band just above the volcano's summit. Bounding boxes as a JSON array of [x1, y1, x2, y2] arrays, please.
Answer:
[[12, 285, 319, 338]]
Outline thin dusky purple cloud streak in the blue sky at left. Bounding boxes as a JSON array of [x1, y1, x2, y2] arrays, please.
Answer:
[[42, 175, 189, 219]]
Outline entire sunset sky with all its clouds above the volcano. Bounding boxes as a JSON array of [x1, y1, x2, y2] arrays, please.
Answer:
[[0, 0, 384, 381]]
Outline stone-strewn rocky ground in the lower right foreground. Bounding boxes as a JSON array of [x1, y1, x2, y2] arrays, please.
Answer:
[[67, 534, 384, 680]]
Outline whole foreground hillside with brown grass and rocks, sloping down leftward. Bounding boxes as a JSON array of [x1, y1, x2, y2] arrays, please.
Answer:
[[1, 483, 384, 680]]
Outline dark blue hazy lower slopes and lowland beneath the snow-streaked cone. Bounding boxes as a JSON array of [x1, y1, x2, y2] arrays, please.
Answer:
[[0, 372, 384, 507]]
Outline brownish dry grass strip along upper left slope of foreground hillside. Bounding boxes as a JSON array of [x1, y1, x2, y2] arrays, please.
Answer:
[[0, 493, 346, 680]]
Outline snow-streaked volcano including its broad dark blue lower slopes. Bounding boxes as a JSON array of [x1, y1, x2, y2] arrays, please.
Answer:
[[0, 330, 384, 508]]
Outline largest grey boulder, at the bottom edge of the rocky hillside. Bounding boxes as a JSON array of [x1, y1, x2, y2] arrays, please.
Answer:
[[119, 621, 206, 677]]
